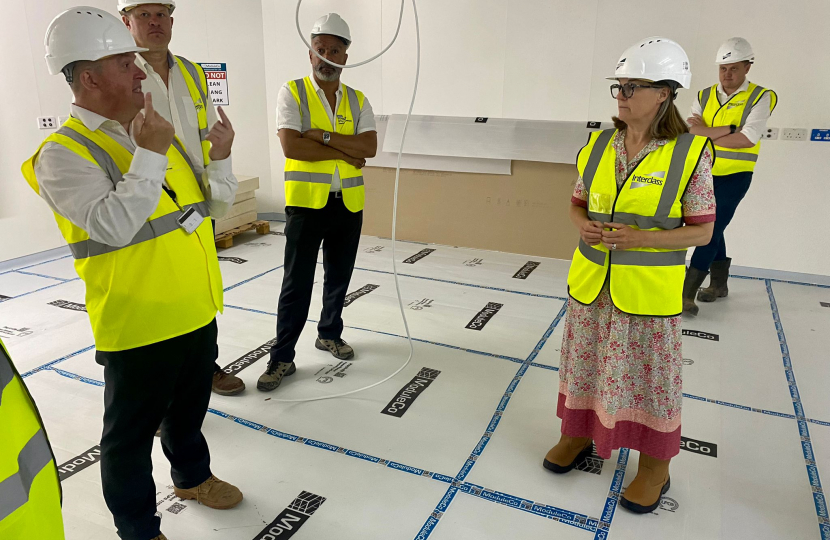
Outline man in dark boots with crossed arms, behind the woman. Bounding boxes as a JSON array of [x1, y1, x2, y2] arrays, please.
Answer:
[[683, 37, 778, 315]]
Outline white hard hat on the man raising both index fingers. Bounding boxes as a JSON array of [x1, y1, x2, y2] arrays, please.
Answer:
[[44, 6, 149, 75]]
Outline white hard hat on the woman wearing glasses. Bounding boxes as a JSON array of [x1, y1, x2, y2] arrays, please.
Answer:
[[608, 37, 692, 88]]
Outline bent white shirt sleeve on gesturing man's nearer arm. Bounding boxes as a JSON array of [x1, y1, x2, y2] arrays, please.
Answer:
[[35, 142, 167, 247]]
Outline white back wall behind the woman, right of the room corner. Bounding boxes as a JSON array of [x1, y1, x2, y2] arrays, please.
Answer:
[[263, 0, 830, 275]]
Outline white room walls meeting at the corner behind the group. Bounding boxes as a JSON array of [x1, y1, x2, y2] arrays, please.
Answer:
[[0, 0, 830, 274]]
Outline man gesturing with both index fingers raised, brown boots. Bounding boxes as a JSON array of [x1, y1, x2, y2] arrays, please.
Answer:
[[23, 7, 242, 540]]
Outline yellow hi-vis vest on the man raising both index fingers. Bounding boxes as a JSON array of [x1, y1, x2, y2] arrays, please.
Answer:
[[23, 118, 223, 351]]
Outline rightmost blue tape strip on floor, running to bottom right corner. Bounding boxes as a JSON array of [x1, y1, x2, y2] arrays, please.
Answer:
[[765, 279, 830, 540]]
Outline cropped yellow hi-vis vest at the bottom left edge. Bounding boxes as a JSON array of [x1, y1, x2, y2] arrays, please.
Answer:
[[0, 341, 64, 540]]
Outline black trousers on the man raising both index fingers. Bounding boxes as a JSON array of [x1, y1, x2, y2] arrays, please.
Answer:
[[95, 320, 217, 540]]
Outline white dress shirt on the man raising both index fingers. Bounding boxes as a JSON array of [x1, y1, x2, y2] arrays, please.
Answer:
[[35, 104, 236, 247]]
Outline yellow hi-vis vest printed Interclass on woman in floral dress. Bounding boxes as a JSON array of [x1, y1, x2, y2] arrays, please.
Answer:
[[568, 129, 711, 317]]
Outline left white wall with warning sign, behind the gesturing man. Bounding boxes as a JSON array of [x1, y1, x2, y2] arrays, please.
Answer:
[[0, 0, 277, 260]]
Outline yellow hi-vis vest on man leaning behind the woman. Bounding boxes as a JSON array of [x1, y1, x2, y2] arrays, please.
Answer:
[[697, 83, 778, 176]]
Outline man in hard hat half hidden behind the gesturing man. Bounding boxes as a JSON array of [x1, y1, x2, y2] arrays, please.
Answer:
[[118, 0, 245, 396]]
